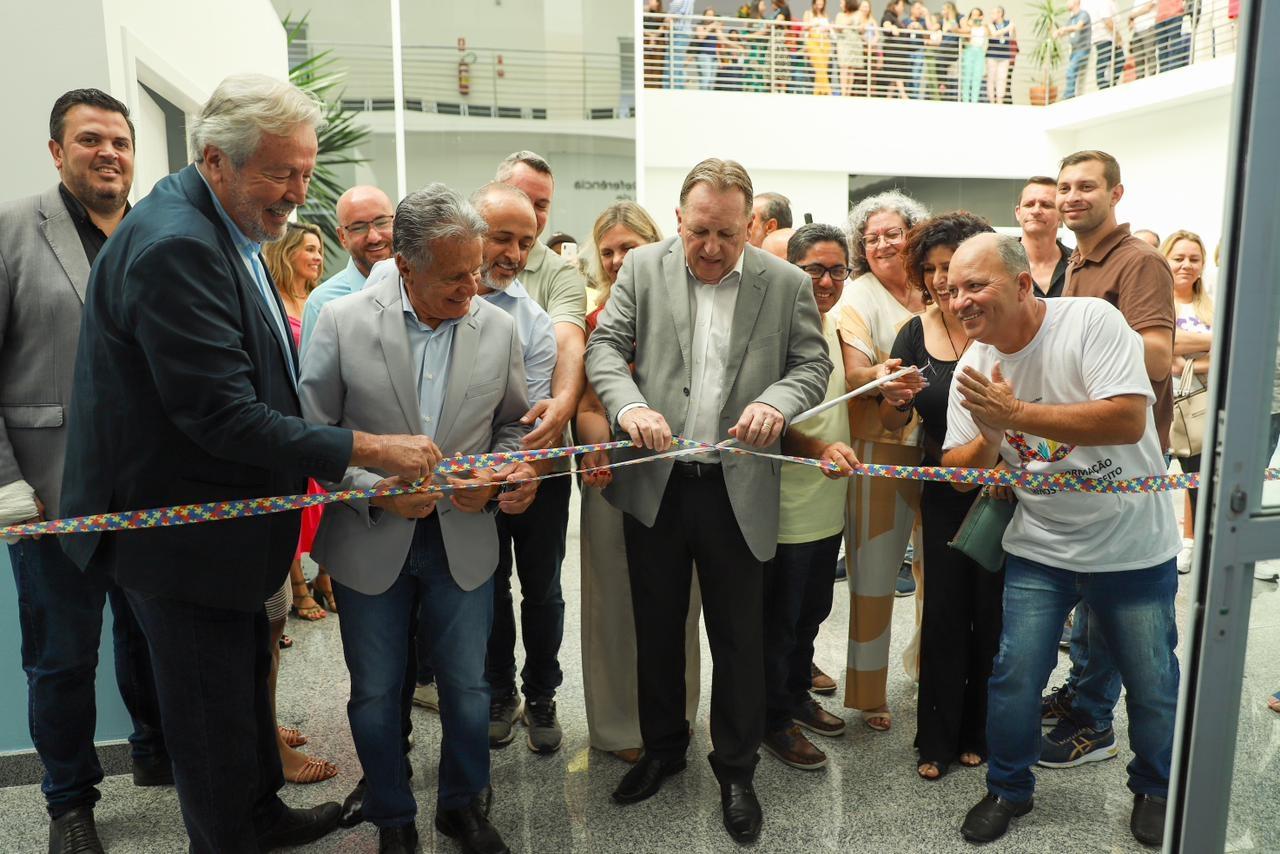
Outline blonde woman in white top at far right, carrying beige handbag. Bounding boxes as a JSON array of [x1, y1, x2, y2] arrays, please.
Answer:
[[1160, 229, 1213, 572]]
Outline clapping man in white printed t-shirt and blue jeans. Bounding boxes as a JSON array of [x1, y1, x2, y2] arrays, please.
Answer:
[[942, 234, 1181, 845]]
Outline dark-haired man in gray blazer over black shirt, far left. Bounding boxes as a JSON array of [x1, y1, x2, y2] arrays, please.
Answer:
[[0, 90, 173, 851]]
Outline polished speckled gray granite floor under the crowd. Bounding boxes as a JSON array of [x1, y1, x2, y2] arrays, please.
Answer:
[[0, 486, 1280, 854]]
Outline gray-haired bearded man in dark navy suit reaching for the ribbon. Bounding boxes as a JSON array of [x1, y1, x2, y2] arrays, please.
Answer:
[[61, 74, 439, 854]]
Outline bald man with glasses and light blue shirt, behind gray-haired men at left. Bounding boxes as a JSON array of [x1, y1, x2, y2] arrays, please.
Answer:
[[300, 184, 396, 353]]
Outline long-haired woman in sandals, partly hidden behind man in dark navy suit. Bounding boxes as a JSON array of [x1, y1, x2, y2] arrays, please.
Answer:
[[252, 223, 338, 784]]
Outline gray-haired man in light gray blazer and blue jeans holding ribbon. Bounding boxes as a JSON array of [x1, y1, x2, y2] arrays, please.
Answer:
[[298, 184, 536, 854]]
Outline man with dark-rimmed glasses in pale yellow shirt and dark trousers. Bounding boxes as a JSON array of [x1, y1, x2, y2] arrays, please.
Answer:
[[763, 223, 858, 771]]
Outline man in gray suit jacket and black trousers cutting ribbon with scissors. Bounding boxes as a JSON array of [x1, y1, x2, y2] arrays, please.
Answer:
[[586, 159, 832, 842]]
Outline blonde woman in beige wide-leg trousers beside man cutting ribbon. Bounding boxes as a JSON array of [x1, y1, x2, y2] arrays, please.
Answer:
[[576, 201, 701, 763]]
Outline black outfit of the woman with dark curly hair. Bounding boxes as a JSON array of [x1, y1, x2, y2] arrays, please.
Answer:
[[892, 318, 1005, 771]]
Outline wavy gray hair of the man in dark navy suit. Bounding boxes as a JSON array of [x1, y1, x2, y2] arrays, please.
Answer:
[[189, 74, 325, 169]]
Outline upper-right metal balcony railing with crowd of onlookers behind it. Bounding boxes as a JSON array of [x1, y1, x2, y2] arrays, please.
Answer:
[[643, 0, 1238, 104]]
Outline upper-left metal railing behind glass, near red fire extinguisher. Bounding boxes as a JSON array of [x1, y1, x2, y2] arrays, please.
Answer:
[[305, 41, 635, 119]]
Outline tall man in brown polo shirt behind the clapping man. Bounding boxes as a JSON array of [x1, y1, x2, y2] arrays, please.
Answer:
[[1039, 151, 1176, 768]]
